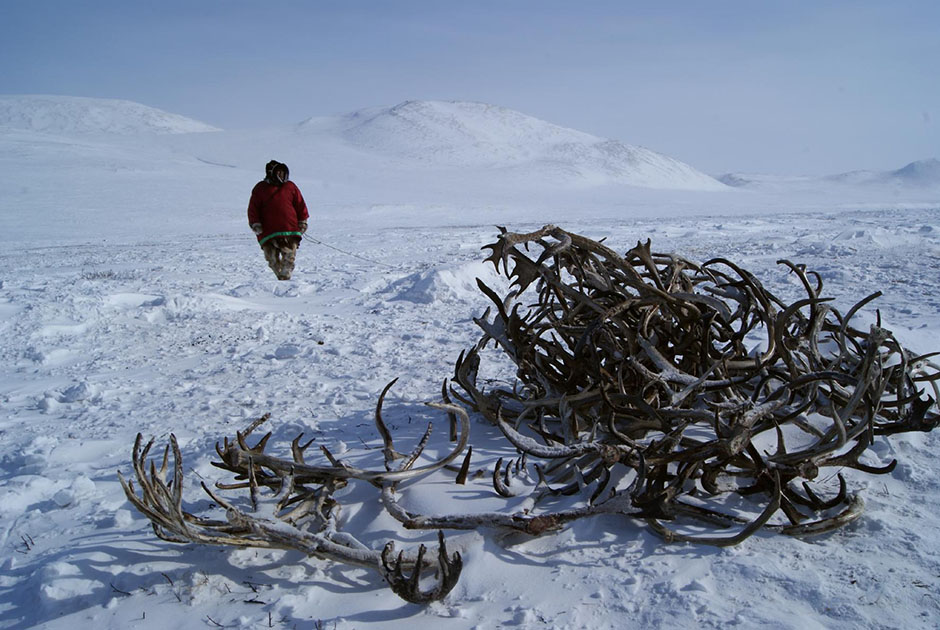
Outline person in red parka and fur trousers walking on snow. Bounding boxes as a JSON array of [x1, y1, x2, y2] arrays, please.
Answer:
[[248, 160, 309, 280]]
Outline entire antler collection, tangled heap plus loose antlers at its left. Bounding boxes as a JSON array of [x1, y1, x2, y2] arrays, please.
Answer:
[[121, 226, 940, 603]]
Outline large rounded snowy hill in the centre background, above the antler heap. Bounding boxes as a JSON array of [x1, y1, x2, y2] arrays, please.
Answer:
[[343, 101, 725, 190]]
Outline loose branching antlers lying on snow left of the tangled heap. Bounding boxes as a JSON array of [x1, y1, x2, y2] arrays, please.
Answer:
[[118, 381, 470, 603]]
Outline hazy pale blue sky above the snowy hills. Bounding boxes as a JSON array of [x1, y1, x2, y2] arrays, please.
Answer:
[[0, 0, 940, 174]]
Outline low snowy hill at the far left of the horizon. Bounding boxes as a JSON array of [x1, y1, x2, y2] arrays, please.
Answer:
[[0, 96, 218, 135]]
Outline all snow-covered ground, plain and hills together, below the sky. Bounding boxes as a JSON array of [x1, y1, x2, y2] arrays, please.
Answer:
[[0, 97, 940, 630]]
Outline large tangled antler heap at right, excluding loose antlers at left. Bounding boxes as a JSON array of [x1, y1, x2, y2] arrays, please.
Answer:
[[455, 225, 940, 545]]
